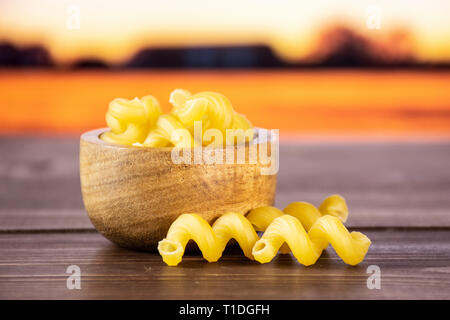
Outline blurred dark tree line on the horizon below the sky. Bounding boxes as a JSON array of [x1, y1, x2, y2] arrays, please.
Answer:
[[0, 26, 450, 69]]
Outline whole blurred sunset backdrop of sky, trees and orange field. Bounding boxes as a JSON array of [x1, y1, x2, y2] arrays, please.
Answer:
[[0, 0, 450, 140]]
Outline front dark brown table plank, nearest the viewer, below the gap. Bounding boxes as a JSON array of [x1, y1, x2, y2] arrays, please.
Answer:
[[0, 230, 450, 299]]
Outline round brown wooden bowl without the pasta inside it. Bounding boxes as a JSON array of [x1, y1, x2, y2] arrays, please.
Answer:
[[80, 129, 278, 250]]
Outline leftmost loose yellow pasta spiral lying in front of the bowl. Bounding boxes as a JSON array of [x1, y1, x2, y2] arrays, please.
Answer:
[[158, 212, 258, 266]]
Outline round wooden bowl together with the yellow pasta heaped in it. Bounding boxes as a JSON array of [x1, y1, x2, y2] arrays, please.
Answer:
[[80, 91, 278, 250]]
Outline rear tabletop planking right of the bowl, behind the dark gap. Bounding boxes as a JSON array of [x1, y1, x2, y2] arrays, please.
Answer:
[[277, 143, 450, 227]]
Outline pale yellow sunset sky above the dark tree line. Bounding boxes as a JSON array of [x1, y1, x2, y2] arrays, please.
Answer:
[[0, 0, 450, 62]]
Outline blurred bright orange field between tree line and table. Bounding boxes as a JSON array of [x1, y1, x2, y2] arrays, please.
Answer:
[[0, 71, 450, 139]]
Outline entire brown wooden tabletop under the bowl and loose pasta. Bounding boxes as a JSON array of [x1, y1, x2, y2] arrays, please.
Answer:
[[0, 137, 450, 299]]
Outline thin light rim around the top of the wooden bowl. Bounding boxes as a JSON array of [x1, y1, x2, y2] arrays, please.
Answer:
[[80, 127, 278, 151]]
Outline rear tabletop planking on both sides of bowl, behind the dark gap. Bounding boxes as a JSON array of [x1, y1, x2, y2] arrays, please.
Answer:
[[0, 137, 450, 231]]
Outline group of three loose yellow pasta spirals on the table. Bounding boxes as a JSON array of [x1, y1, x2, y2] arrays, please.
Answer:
[[158, 195, 371, 266]]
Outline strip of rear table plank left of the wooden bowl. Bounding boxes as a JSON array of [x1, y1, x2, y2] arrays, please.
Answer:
[[0, 137, 83, 210]]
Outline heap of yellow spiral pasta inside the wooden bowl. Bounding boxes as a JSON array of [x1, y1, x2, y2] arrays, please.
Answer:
[[101, 89, 253, 148]]
